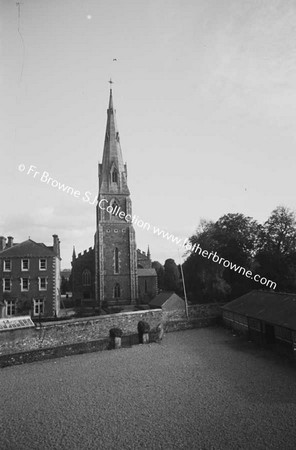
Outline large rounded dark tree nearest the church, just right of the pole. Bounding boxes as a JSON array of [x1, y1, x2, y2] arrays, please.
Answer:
[[184, 213, 261, 302]]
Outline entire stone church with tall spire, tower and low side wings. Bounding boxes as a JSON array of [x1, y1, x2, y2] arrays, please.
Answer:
[[71, 86, 158, 310]]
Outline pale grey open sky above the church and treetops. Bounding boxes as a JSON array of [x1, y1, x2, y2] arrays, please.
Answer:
[[0, 0, 296, 268]]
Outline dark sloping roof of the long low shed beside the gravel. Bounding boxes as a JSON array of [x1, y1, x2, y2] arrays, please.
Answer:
[[222, 290, 296, 330]]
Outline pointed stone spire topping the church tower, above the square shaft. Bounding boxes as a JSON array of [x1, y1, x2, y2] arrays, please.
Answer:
[[99, 84, 129, 195]]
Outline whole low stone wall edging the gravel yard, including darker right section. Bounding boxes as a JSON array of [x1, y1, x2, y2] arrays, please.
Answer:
[[0, 304, 221, 360]]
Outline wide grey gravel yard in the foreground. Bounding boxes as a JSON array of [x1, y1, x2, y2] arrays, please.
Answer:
[[0, 327, 296, 450]]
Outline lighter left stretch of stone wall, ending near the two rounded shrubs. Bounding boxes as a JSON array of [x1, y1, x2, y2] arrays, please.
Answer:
[[0, 309, 162, 355]]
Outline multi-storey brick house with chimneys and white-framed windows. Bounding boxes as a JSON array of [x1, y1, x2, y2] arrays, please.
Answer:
[[0, 235, 61, 318]]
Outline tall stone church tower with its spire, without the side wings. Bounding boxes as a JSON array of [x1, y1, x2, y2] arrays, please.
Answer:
[[95, 88, 138, 307]]
